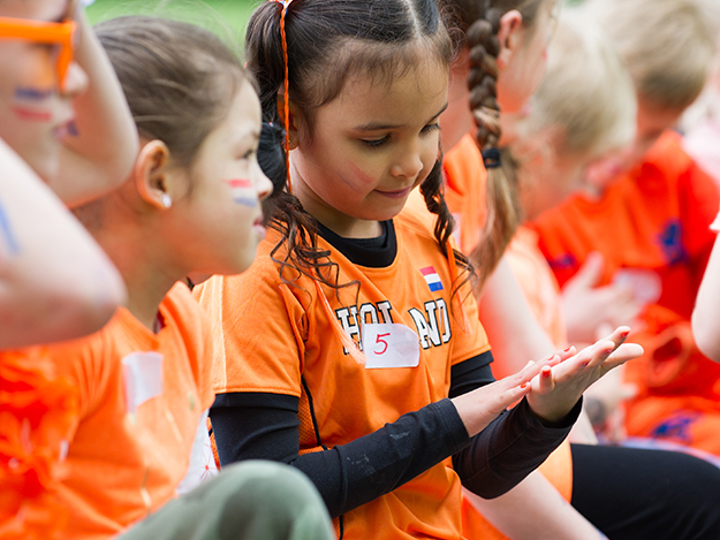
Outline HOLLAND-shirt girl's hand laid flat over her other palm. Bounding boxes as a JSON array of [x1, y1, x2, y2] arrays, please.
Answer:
[[452, 351, 577, 437]]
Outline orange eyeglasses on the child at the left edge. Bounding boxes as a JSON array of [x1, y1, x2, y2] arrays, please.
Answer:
[[0, 17, 77, 88]]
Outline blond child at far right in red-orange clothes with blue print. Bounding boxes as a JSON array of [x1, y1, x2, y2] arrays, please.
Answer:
[[536, 0, 720, 455]]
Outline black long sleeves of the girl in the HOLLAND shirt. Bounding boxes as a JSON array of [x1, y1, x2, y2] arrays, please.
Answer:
[[210, 352, 580, 517]]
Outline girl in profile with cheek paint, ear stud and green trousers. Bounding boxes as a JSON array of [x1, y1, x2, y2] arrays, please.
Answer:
[[13, 18, 331, 540]]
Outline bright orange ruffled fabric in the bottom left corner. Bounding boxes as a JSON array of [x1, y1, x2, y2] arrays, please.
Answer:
[[0, 347, 78, 540]]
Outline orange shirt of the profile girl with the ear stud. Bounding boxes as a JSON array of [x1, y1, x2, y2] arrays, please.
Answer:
[[16, 283, 214, 540]]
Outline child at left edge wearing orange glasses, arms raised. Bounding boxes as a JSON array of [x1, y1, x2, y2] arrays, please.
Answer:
[[0, 0, 137, 538]]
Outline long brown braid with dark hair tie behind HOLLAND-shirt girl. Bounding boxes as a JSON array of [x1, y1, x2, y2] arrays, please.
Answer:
[[466, 1, 520, 287]]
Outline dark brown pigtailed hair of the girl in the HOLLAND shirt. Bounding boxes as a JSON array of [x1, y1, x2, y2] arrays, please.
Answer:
[[245, 0, 469, 296]]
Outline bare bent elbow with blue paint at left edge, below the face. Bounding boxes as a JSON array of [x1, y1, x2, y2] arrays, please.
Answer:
[[0, 140, 125, 349]]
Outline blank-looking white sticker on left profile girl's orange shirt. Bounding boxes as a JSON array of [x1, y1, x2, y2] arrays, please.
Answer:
[[122, 352, 163, 414]]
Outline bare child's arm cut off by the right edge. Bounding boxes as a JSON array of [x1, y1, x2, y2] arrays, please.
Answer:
[[692, 220, 720, 362]]
